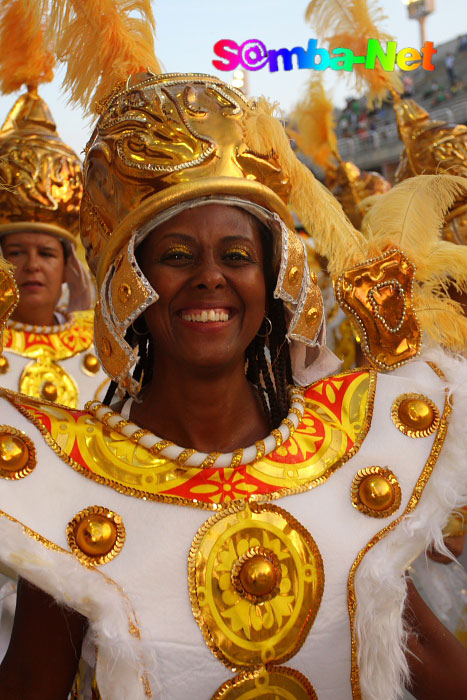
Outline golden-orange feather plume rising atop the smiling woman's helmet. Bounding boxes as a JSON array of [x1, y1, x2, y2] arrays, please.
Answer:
[[47, 0, 161, 112]]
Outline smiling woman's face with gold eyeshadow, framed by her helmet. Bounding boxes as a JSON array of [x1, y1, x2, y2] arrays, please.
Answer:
[[138, 204, 266, 371]]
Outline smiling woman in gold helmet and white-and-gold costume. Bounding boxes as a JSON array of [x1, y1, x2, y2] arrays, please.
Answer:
[[0, 2, 467, 700]]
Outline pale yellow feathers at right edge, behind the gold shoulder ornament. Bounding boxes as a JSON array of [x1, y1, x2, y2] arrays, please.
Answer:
[[362, 174, 467, 352]]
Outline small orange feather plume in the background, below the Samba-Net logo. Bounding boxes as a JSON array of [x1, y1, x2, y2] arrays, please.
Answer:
[[290, 74, 338, 169]]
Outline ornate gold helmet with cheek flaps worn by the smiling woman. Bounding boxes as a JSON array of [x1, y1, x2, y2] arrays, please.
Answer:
[[81, 73, 334, 391]]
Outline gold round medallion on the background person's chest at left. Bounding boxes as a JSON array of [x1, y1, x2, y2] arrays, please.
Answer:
[[19, 357, 78, 408]]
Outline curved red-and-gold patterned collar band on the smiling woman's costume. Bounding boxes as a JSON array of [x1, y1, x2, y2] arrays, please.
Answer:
[[3, 370, 376, 510]]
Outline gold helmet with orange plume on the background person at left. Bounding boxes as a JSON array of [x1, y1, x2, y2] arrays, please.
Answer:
[[0, 0, 92, 311]]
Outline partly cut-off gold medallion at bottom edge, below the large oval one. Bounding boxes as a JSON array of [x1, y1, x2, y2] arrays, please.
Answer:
[[212, 666, 318, 700]]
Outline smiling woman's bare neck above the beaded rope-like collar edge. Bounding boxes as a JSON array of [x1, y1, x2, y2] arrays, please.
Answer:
[[130, 366, 269, 452]]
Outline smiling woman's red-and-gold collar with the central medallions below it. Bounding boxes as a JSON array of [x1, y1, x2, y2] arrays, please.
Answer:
[[2, 370, 376, 700]]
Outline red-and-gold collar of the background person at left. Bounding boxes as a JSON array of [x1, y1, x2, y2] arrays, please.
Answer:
[[3, 311, 94, 361]]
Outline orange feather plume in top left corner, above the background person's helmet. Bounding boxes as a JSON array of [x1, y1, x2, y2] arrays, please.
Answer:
[[0, 0, 55, 93]]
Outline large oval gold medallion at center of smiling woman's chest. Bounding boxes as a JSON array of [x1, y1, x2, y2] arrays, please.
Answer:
[[188, 503, 324, 668]]
